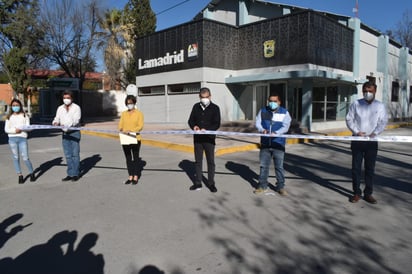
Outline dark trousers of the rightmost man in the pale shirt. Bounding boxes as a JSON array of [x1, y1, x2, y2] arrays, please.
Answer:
[[351, 141, 378, 195]]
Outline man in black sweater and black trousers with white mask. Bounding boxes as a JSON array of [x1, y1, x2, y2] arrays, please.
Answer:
[[188, 87, 220, 192]]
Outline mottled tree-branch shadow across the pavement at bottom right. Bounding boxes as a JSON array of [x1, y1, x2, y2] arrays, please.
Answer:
[[196, 193, 402, 274]]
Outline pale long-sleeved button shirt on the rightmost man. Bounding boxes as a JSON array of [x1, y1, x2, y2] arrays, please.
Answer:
[[346, 99, 388, 136]]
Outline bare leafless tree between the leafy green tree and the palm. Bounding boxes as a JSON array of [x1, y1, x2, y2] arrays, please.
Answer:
[[41, 0, 101, 89]]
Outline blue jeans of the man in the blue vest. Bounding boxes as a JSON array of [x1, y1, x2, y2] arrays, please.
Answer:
[[259, 148, 285, 189]]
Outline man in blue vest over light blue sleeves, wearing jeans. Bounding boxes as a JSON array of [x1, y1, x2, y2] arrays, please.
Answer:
[[253, 94, 292, 195]]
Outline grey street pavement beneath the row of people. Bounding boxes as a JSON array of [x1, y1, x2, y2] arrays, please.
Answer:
[[0, 124, 412, 274]]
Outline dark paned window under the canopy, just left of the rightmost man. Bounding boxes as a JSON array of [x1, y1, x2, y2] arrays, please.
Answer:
[[312, 87, 339, 122]]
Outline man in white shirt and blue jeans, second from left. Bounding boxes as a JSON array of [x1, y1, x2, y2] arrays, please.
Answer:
[[52, 90, 82, 182]]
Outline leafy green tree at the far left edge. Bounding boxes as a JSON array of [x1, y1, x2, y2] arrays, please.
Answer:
[[0, 0, 44, 98]]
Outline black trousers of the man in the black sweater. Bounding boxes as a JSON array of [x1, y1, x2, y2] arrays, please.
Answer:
[[194, 142, 216, 185]]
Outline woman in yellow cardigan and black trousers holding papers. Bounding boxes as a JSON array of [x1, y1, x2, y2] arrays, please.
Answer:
[[119, 95, 144, 185]]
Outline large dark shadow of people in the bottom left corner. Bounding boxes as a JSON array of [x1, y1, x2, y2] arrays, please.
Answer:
[[0, 230, 104, 274]]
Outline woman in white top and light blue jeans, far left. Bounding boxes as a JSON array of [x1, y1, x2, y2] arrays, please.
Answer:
[[4, 99, 36, 184]]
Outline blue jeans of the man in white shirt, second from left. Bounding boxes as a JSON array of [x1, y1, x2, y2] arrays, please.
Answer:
[[63, 130, 80, 177]]
